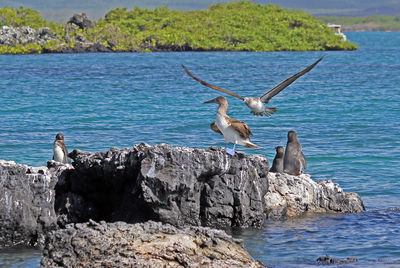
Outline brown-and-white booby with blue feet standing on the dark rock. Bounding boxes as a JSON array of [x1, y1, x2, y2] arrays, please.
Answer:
[[204, 97, 260, 155]]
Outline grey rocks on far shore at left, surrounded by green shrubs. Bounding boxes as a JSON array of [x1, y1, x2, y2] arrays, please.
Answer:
[[0, 26, 55, 46]]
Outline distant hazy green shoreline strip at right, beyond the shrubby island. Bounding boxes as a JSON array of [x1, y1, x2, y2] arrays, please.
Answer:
[[319, 14, 400, 31]]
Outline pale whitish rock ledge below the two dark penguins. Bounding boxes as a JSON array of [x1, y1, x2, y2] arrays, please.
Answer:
[[265, 172, 365, 219]]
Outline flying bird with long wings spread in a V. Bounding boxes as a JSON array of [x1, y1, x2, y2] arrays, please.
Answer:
[[182, 57, 323, 117]]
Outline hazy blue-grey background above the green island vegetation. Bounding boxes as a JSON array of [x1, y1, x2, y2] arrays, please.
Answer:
[[0, 0, 400, 22]]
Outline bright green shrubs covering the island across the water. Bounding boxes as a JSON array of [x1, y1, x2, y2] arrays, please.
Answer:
[[0, 1, 357, 53]]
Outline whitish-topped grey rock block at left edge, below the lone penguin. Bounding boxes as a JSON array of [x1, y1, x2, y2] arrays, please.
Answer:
[[0, 160, 57, 248]]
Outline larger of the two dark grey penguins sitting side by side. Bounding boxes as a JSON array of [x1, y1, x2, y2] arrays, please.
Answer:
[[283, 130, 307, 176]]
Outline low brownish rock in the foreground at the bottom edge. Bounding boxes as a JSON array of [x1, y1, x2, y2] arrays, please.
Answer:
[[41, 221, 264, 268]]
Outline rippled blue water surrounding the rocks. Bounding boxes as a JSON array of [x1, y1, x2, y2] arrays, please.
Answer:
[[0, 32, 400, 267]]
